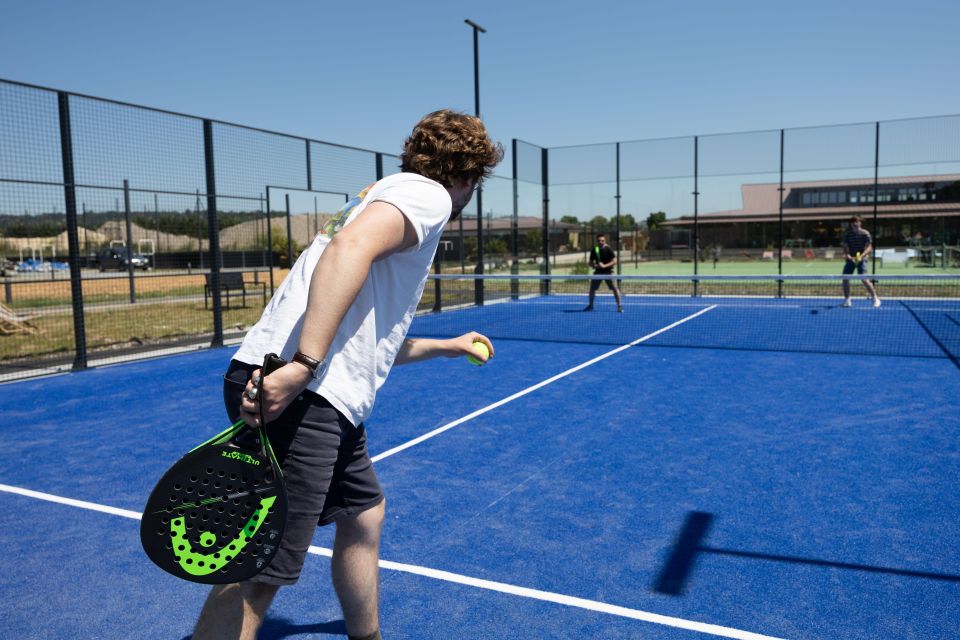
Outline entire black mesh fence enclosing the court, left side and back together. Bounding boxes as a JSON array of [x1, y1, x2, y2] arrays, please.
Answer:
[[0, 81, 960, 381]]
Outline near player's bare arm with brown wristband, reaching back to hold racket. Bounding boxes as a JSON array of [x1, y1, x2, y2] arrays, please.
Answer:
[[241, 202, 417, 424]]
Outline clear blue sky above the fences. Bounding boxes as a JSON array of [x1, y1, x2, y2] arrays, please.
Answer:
[[0, 0, 960, 173]]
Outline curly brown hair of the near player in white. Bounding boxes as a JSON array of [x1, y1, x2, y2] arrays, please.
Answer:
[[400, 109, 503, 187]]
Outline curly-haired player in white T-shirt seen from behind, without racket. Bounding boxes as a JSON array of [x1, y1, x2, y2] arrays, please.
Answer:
[[193, 110, 503, 640]]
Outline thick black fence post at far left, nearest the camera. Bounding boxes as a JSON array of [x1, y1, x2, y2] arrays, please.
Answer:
[[57, 91, 87, 369]]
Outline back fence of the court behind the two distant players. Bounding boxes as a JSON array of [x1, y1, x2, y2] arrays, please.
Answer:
[[516, 116, 960, 276]]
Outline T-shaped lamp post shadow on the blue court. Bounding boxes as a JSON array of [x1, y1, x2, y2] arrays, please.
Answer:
[[653, 511, 960, 596]]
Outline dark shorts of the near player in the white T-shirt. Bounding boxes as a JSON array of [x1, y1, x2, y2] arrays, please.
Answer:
[[223, 360, 383, 585]]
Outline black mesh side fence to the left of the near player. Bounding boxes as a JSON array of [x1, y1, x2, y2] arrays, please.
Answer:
[[0, 81, 399, 381]]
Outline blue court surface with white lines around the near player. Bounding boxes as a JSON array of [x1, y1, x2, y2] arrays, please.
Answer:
[[0, 296, 960, 640]]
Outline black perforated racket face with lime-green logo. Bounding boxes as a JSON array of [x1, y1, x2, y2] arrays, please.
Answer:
[[140, 443, 287, 584]]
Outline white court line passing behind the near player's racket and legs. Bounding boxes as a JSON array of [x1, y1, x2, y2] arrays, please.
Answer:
[[0, 484, 783, 640]]
